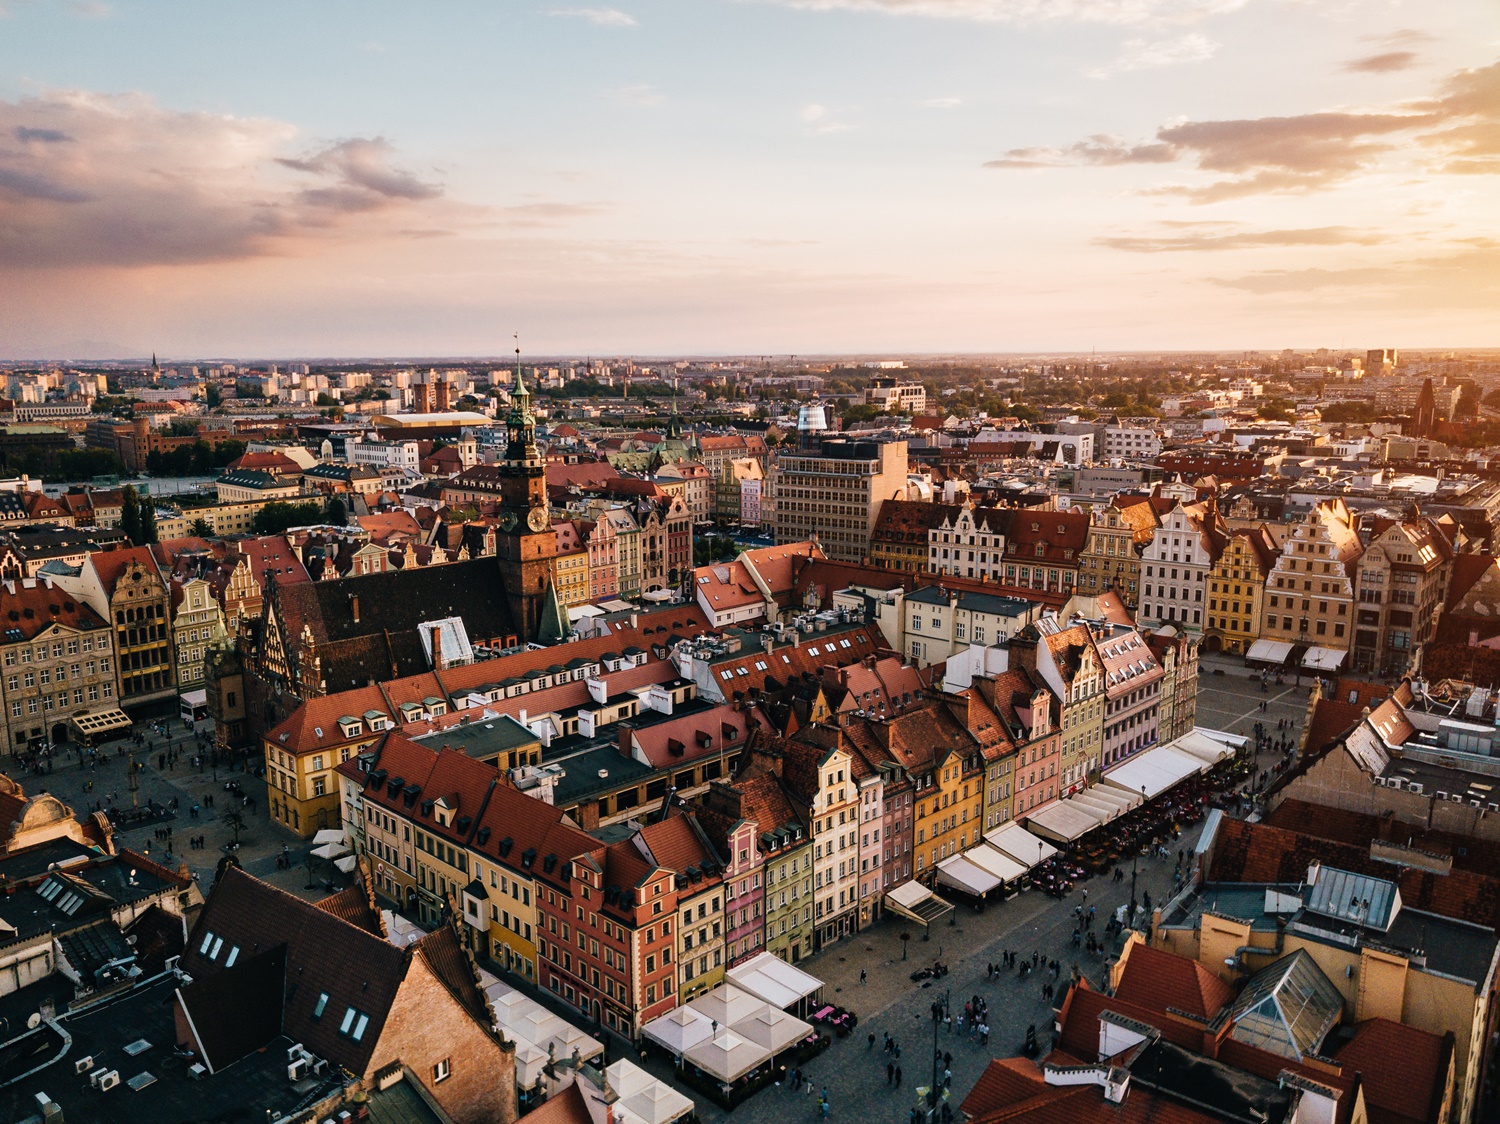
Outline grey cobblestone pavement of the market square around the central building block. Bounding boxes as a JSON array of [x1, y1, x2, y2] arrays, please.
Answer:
[[21, 675, 1308, 1124]]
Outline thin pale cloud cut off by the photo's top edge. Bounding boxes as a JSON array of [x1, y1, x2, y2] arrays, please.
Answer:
[[756, 0, 1248, 24]]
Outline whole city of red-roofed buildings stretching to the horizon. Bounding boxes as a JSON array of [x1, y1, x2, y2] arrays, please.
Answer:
[[0, 348, 1500, 1124]]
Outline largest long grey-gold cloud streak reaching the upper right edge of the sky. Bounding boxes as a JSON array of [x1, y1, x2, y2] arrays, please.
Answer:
[[984, 63, 1500, 203]]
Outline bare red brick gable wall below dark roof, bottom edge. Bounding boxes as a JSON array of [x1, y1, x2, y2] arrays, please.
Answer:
[[365, 957, 516, 1124]]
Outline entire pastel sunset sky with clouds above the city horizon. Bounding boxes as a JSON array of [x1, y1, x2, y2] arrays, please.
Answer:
[[0, 0, 1500, 360]]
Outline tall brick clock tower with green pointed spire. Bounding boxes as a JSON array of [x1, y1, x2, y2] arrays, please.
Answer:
[[495, 363, 558, 641]]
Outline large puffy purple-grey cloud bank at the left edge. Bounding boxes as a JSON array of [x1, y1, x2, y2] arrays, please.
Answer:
[[0, 90, 443, 269]]
